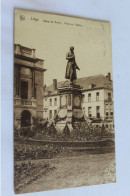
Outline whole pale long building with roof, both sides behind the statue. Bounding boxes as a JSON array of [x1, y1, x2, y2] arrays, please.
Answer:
[[44, 73, 113, 125]]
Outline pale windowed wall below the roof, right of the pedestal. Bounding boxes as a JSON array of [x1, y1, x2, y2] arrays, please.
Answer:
[[82, 88, 113, 120]]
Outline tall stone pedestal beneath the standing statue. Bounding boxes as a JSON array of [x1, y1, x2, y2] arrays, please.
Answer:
[[56, 84, 84, 132]]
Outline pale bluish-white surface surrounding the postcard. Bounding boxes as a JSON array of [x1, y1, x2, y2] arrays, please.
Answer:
[[1, 0, 130, 196]]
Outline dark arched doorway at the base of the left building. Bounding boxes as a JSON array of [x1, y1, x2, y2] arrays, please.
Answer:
[[21, 110, 31, 127]]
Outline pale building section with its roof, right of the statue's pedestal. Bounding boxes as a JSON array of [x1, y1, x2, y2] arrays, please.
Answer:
[[81, 73, 113, 120]]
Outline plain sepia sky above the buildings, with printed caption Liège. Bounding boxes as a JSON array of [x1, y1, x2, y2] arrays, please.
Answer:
[[14, 10, 112, 86]]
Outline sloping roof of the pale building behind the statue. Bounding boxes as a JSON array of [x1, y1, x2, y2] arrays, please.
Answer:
[[45, 74, 113, 95]]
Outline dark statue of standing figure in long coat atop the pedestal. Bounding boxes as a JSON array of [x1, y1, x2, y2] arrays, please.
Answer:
[[65, 46, 80, 83]]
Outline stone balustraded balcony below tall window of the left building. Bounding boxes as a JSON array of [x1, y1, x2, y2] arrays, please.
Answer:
[[14, 97, 36, 107]]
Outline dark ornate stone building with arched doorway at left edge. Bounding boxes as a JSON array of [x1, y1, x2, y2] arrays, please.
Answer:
[[14, 44, 46, 126]]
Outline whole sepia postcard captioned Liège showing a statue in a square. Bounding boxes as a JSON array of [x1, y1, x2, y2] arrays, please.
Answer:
[[14, 9, 116, 194]]
